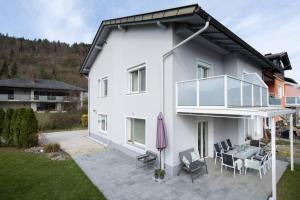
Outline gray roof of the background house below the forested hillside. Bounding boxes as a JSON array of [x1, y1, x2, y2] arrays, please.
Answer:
[[0, 78, 85, 91]]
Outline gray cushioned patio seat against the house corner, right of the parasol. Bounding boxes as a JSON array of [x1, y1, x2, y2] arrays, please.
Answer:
[[177, 148, 208, 183]]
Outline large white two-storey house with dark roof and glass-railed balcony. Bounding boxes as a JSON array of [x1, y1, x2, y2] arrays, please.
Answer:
[[80, 4, 296, 200]]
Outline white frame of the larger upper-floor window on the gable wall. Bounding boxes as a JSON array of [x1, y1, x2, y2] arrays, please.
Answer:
[[127, 63, 147, 94]]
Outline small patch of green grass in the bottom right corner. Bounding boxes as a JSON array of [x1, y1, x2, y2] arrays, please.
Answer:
[[277, 165, 300, 200]]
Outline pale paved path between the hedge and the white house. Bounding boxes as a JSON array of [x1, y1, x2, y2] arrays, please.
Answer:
[[40, 130, 105, 157]]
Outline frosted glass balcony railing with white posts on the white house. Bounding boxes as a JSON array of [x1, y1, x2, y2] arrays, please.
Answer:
[[176, 75, 269, 107]]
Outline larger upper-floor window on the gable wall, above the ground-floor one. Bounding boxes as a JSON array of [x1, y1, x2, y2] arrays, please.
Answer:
[[129, 67, 146, 93]]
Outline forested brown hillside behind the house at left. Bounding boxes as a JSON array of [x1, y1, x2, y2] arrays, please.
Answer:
[[0, 34, 89, 88]]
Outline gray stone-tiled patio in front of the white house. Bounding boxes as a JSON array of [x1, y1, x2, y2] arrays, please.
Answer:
[[73, 149, 287, 200]]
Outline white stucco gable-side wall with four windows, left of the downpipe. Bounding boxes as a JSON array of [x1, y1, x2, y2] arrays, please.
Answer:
[[89, 25, 172, 163]]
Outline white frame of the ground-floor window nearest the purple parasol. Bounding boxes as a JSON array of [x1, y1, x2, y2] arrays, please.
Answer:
[[125, 116, 147, 150]]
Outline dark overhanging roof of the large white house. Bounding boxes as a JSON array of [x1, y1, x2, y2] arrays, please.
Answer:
[[80, 4, 280, 74]]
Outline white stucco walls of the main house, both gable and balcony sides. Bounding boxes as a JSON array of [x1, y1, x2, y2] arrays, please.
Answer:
[[89, 25, 261, 173]]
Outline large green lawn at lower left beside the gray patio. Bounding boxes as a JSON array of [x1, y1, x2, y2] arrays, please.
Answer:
[[0, 147, 105, 200]]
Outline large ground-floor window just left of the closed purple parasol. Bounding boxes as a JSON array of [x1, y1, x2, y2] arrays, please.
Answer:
[[127, 118, 146, 146]]
